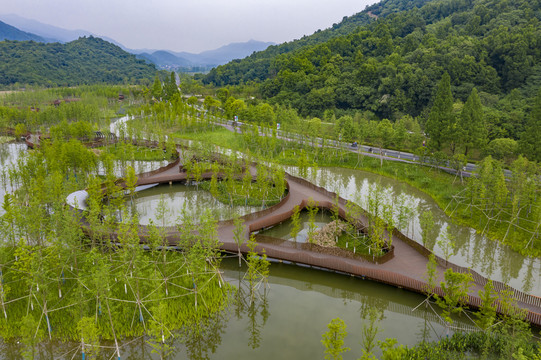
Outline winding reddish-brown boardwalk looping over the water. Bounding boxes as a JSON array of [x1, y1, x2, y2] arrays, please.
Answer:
[[66, 160, 541, 326]]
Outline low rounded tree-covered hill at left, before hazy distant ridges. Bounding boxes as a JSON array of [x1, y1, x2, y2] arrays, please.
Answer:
[[0, 36, 156, 86]]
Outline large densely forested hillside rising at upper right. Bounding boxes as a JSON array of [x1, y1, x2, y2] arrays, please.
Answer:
[[204, 0, 541, 154]]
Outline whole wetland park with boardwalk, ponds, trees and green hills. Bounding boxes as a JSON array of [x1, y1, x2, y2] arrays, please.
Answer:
[[0, 0, 541, 359]]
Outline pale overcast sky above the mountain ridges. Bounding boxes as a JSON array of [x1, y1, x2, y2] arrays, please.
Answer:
[[0, 0, 377, 53]]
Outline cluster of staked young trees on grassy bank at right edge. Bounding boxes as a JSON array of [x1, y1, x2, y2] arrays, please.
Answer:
[[456, 156, 541, 256]]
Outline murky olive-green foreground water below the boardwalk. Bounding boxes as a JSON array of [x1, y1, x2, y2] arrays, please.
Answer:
[[0, 257, 465, 360]]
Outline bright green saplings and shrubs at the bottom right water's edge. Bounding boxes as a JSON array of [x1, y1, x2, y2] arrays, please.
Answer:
[[321, 268, 541, 360]]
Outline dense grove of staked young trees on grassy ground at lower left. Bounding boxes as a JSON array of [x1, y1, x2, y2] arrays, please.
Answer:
[[0, 131, 243, 358]]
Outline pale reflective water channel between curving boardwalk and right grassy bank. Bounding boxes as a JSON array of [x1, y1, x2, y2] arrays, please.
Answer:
[[287, 167, 541, 296]]
